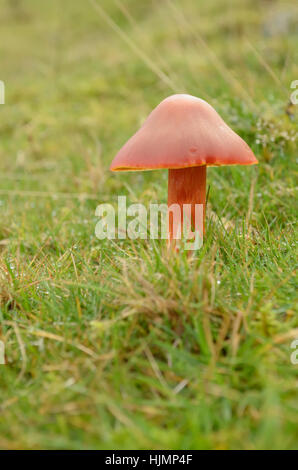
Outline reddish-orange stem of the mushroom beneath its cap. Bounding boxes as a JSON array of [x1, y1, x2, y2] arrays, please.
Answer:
[[168, 165, 206, 242]]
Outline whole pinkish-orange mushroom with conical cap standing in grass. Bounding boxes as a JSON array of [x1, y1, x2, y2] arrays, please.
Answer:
[[110, 94, 258, 248]]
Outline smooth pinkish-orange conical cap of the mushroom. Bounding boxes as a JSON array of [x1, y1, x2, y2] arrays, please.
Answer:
[[110, 94, 258, 171]]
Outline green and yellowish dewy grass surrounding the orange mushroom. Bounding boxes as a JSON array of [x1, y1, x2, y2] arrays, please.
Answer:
[[0, 0, 298, 449]]
